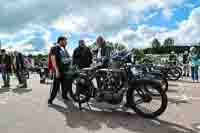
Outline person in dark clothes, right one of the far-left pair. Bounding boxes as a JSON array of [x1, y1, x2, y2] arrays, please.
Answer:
[[13, 51, 27, 88]]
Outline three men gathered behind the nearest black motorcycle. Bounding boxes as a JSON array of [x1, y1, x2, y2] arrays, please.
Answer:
[[48, 36, 111, 104]]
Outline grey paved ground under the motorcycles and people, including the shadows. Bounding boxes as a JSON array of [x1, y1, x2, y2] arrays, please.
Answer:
[[0, 75, 200, 133]]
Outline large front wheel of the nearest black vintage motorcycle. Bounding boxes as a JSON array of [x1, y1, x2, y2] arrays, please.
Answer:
[[127, 80, 168, 119]]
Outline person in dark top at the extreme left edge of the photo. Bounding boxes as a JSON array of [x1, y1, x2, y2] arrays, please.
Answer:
[[0, 49, 11, 87]]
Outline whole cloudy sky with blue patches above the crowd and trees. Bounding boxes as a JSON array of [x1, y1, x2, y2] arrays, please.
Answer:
[[0, 0, 200, 53]]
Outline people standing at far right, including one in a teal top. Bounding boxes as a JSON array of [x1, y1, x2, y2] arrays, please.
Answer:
[[169, 47, 200, 83]]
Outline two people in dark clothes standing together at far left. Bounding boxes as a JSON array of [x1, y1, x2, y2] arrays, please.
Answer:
[[0, 49, 30, 88]]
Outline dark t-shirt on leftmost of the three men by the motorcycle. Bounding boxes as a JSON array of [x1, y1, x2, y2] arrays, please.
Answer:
[[51, 46, 71, 74]]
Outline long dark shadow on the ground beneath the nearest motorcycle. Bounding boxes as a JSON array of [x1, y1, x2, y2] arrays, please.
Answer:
[[49, 102, 197, 133]]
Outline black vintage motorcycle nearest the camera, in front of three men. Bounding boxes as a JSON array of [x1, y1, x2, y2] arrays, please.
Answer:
[[70, 53, 168, 118]]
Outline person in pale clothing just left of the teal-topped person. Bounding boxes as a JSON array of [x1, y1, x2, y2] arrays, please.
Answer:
[[183, 51, 190, 77]]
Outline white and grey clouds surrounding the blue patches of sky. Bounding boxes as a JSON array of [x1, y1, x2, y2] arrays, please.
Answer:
[[0, 0, 195, 54]]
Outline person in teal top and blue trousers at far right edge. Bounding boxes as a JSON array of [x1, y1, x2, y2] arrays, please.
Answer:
[[190, 47, 199, 83]]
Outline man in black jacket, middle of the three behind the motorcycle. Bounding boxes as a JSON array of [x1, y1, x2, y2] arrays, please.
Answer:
[[73, 40, 92, 69]]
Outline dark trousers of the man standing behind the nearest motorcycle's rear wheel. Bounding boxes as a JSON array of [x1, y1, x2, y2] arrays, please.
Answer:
[[49, 78, 72, 101]]
